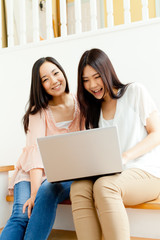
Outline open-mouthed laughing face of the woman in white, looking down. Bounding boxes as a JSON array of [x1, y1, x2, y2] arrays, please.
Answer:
[[82, 65, 105, 99]]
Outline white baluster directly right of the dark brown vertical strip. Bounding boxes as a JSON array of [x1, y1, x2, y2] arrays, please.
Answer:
[[60, 0, 67, 36]]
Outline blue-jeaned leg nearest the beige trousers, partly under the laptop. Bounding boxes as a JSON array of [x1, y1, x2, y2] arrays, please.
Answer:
[[24, 180, 72, 240]]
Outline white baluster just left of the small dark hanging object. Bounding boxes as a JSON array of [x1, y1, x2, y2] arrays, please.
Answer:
[[32, 0, 40, 42]]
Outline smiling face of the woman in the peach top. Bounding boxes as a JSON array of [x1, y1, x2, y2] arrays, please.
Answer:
[[39, 61, 66, 97]]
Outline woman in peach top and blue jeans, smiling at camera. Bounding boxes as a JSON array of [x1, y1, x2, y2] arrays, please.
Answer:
[[0, 57, 79, 240]]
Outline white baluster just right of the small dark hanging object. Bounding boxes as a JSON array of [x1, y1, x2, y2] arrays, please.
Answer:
[[46, 0, 53, 39]]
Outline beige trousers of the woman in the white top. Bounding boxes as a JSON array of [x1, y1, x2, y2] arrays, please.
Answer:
[[70, 169, 160, 240]]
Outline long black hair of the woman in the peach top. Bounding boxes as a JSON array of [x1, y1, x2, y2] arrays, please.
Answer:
[[23, 57, 69, 133]]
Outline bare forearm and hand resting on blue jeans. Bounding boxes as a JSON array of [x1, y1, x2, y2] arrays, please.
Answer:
[[23, 168, 42, 218]]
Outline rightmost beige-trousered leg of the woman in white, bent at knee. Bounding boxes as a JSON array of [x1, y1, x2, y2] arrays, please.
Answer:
[[93, 169, 160, 240]]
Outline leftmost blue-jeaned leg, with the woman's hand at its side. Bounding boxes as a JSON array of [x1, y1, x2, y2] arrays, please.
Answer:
[[0, 182, 30, 240]]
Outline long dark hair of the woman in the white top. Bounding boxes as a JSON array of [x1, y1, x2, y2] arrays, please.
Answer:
[[77, 48, 128, 129]]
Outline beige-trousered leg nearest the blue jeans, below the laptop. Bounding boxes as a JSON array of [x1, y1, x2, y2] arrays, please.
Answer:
[[70, 180, 102, 240]]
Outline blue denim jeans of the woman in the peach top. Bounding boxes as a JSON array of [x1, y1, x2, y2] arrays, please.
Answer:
[[0, 180, 72, 240]]
